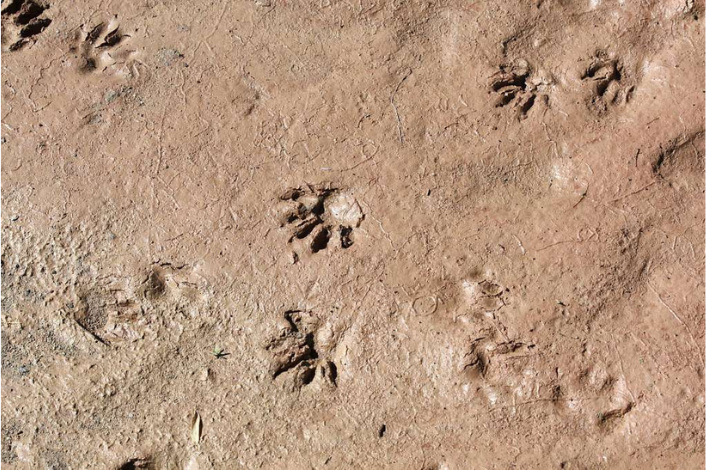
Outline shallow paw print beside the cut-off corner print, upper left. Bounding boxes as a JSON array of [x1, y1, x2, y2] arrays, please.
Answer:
[[70, 19, 135, 74]]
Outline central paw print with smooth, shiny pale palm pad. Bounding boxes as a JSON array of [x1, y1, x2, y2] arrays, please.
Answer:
[[276, 185, 363, 260]]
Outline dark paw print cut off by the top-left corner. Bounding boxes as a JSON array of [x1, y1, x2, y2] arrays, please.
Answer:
[[2, 0, 51, 51]]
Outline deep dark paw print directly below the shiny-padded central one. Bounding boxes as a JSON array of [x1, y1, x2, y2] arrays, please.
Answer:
[[265, 310, 337, 389]]
